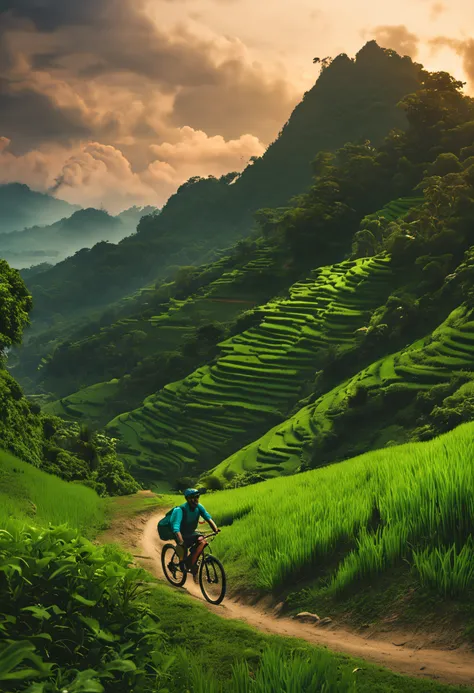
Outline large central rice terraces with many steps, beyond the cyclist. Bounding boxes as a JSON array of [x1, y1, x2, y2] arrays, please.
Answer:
[[107, 251, 396, 483]]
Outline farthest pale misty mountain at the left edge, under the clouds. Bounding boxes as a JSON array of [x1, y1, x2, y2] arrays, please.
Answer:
[[0, 183, 80, 234]]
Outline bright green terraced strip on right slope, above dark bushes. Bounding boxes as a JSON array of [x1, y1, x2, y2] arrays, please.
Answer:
[[213, 307, 474, 479]]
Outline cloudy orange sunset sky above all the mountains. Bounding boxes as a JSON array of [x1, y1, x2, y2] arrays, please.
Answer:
[[0, 0, 474, 213]]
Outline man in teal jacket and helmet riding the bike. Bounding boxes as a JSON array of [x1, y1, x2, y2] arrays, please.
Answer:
[[170, 488, 220, 574]]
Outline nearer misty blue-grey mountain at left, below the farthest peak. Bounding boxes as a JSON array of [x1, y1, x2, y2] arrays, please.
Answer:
[[0, 207, 157, 266]]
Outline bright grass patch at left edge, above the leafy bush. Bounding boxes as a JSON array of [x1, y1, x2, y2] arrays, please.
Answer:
[[0, 451, 106, 536]]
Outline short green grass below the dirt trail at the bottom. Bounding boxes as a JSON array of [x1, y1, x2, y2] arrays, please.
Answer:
[[145, 585, 467, 693]]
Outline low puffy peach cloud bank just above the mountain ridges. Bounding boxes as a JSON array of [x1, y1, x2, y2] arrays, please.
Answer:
[[0, 127, 265, 213]]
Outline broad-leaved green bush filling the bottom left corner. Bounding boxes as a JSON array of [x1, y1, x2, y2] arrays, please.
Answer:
[[0, 525, 167, 693]]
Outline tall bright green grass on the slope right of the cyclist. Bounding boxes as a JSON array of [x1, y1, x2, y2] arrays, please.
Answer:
[[206, 423, 474, 594]]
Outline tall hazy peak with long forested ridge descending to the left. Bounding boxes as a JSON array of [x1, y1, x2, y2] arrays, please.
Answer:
[[22, 42, 421, 324]]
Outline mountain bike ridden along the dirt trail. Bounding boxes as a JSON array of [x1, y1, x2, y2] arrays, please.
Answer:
[[161, 532, 227, 604]]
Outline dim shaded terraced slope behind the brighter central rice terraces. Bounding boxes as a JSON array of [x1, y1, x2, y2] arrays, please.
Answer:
[[43, 244, 288, 426]]
